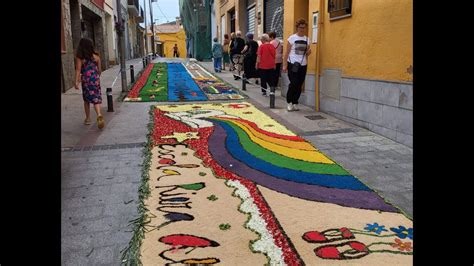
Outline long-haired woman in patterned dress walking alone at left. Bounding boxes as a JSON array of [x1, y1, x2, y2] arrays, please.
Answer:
[[74, 38, 105, 129]]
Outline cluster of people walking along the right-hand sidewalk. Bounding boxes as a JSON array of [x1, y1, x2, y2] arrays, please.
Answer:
[[212, 19, 311, 111]]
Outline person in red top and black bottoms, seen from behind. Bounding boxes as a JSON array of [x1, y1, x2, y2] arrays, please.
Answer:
[[256, 34, 276, 96]]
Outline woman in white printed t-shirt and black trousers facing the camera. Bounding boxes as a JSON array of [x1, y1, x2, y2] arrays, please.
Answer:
[[283, 19, 311, 111]]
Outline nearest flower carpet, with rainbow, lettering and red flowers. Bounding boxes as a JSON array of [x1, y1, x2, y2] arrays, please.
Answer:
[[123, 102, 413, 265]]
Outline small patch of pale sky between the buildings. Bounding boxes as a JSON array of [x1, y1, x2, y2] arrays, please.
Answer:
[[138, 0, 179, 27]]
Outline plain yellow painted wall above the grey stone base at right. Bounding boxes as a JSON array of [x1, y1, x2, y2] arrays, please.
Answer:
[[316, 0, 413, 82]]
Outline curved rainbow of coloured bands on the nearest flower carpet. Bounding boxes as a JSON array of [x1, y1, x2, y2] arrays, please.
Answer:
[[207, 116, 399, 212]]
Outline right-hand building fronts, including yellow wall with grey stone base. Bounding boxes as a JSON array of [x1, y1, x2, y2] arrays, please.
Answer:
[[214, 0, 413, 146]]
